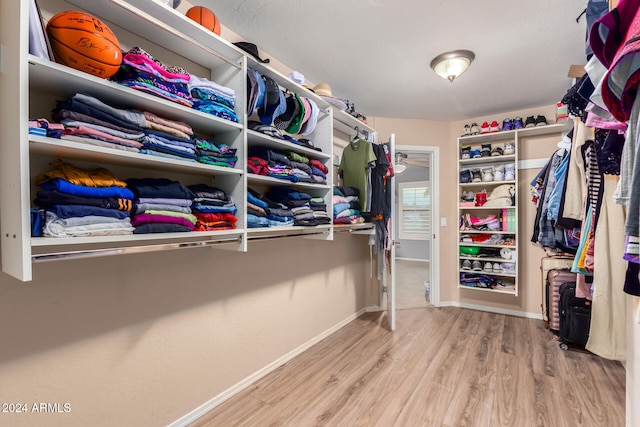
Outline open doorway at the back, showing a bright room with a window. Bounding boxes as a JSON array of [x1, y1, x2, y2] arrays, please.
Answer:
[[393, 145, 439, 309]]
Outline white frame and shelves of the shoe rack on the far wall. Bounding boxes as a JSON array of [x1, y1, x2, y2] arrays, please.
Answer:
[[458, 124, 564, 296]]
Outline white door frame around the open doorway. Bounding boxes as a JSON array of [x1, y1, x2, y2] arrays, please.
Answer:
[[392, 145, 441, 308]]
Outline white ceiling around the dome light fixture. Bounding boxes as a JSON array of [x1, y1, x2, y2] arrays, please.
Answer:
[[199, 0, 587, 121]]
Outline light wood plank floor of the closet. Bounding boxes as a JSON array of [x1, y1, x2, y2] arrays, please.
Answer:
[[194, 307, 625, 427]]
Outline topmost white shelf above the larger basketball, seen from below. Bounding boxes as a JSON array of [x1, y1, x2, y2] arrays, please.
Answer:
[[69, 0, 243, 69]]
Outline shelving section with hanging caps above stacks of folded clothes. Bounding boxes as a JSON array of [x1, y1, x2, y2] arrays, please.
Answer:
[[246, 53, 333, 241]]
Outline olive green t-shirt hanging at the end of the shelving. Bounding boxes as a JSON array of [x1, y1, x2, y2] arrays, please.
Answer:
[[339, 139, 376, 208]]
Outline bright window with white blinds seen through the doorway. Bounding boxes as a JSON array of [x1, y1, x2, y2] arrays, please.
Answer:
[[398, 181, 431, 240]]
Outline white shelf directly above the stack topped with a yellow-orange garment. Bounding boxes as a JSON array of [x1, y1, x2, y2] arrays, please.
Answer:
[[29, 135, 243, 176]]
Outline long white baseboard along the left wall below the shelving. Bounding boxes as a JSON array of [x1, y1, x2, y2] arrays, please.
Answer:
[[169, 307, 374, 427]]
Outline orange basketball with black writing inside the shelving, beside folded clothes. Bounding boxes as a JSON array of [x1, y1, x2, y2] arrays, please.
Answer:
[[47, 10, 122, 79]]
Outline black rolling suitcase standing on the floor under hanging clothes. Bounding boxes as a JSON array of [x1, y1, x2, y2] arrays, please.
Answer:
[[559, 282, 591, 350]]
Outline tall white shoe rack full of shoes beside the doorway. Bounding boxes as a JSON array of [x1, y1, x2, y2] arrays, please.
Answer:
[[458, 115, 564, 296]]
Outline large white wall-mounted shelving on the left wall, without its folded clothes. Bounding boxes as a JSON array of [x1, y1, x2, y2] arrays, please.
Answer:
[[0, 0, 375, 281]]
